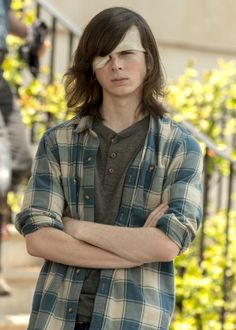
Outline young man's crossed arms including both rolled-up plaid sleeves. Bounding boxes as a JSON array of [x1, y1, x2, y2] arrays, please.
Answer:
[[21, 131, 202, 269]]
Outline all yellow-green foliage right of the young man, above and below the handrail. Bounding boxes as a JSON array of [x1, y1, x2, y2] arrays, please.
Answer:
[[167, 61, 236, 330]]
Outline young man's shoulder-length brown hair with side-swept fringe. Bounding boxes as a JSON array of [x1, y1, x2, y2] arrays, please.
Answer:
[[65, 7, 165, 117]]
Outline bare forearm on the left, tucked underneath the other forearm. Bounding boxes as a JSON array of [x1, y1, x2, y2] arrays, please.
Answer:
[[26, 228, 138, 269]]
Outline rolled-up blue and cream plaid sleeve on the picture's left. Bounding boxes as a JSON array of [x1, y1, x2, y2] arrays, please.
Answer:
[[16, 131, 65, 235]]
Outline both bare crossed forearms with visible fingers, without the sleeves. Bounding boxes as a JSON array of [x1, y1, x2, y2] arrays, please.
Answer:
[[26, 204, 179, 269]]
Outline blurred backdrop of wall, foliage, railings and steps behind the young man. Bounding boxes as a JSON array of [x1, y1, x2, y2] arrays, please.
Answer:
[[0, 0, 236, 330]]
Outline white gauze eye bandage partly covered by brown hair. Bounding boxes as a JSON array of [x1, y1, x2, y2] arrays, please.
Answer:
[[92, 25, 145, 72]]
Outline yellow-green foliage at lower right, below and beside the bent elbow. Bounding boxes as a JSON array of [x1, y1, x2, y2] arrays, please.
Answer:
[[171, 211, 236, 330]]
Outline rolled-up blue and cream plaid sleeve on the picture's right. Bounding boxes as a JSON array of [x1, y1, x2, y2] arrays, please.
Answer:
[[156, 136, 203, 254]]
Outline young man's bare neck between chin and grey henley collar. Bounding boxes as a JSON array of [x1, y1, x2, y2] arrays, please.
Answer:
[[100, 99, 145, 133]]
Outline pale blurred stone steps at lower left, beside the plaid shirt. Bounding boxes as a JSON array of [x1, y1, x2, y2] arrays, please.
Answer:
[[0, 228, 42, 330]]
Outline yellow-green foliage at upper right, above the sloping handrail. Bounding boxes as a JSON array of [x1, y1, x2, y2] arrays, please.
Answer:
[[167, 60, 236, 159]]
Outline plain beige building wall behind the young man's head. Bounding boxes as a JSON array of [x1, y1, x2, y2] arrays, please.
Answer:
[[44, 0, 236, 79]]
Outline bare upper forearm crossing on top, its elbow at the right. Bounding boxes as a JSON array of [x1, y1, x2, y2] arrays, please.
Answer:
[[73, 221, 179, 264]]
